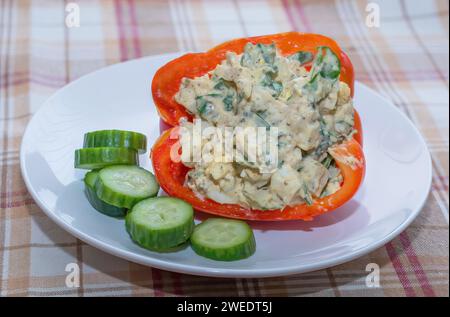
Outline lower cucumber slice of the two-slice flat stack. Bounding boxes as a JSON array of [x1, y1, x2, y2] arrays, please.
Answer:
[[75, 147, 139, 169]]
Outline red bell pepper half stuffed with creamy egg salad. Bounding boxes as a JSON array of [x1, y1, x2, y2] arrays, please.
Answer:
[[151, 32, 365, 220]]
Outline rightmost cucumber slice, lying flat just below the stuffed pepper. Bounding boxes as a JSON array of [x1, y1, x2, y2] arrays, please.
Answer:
[[191, 218, 256, 261]]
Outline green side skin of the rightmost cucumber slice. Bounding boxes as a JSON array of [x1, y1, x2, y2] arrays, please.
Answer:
[[191, 218, 256, 261]]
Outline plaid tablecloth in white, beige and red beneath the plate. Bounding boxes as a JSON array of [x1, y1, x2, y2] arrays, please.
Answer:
[[0, 0, 449, 297]]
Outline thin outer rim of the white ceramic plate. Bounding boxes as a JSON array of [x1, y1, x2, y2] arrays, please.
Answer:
[[19, 52, 433, 278]]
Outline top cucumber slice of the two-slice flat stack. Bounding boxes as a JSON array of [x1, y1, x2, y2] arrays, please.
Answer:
[[83, 130, 147, 154]]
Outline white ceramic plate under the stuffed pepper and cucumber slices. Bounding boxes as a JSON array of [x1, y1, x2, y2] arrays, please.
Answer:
[[20, 54, 431, 277]]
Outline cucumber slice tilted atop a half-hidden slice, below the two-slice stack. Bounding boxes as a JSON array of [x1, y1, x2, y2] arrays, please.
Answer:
[[95, 165, 159, 209]]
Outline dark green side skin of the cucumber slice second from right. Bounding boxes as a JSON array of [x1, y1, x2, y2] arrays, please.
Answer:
[[125, 198, 195, 252]]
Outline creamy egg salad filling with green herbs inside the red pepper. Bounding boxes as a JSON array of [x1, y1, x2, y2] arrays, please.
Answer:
[[175, 43, 355, 210]]
